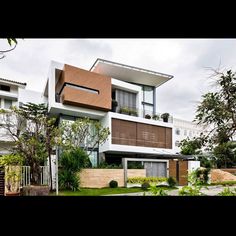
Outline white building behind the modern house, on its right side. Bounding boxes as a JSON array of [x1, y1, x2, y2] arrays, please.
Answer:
[[173, 118, 206, 153]]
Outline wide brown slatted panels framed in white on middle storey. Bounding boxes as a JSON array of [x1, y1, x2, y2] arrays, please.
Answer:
[[112, 119, 172, 149]]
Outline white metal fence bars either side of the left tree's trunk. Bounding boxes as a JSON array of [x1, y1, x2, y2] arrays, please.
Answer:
[[21, 166, 50, 187]]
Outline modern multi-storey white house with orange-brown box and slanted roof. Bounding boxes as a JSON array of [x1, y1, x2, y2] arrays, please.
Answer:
[[44, 59, 199, 183]]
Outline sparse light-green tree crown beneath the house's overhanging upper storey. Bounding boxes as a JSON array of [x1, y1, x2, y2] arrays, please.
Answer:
[[60, 117, 110, 155]]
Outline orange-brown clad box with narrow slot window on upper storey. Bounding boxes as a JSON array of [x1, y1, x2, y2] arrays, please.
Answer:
[[56, 65, 111, 110]]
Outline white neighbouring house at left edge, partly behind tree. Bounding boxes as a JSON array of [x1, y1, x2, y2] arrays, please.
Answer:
[[0, 78, 45, 155]]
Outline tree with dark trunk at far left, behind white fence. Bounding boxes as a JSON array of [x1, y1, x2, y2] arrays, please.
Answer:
[[0, 103, 57, 187]]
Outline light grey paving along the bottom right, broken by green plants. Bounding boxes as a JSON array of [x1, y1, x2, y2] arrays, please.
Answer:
[[106, 186, 236, 196]]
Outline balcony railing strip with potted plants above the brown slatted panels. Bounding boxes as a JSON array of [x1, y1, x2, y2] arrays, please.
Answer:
[[112, 106, 173, 123]]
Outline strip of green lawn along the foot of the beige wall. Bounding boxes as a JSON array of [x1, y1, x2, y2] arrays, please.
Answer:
[[53, 188, 143, 196]]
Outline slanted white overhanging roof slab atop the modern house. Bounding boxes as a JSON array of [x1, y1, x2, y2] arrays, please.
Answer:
[[90, 58, 173, 87]]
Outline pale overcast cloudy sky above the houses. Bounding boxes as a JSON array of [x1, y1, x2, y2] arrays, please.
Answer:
[[0, 38, 236, 121]]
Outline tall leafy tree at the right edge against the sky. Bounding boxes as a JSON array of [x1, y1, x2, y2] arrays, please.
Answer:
[[195, 70, 236, 167]]
